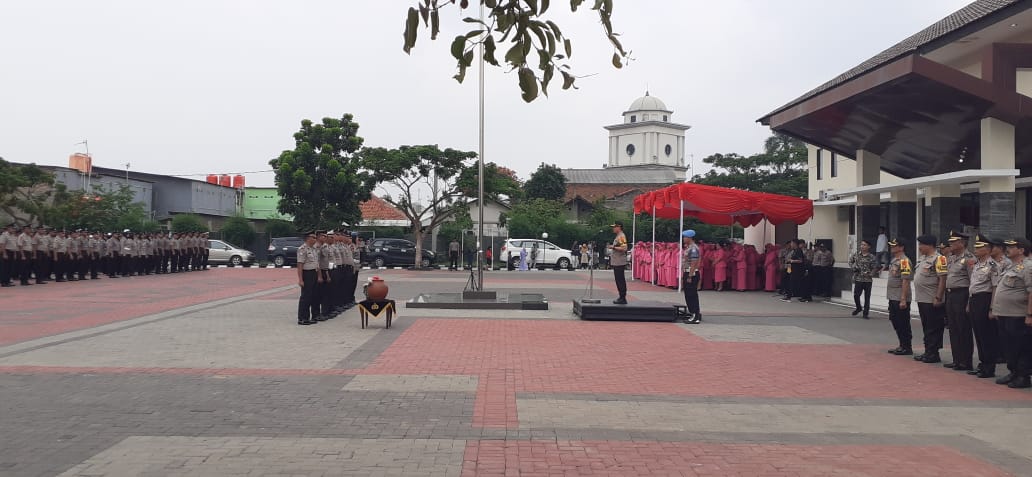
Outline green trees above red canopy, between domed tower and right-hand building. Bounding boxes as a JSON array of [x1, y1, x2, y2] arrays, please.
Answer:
[[696, 133, 807, 197]]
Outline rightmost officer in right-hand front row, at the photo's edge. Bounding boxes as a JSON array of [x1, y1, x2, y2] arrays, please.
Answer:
[[990, 239, 1032, 389]]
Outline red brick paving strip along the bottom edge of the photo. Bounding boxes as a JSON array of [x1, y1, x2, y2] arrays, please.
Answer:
[[461, 441, 1007, 477]]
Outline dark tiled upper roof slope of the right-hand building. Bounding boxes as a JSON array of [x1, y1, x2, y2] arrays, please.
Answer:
[[761, 0, 1019, 121]]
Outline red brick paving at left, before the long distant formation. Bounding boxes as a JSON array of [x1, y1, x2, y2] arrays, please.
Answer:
[[0, 268, 296, 345]]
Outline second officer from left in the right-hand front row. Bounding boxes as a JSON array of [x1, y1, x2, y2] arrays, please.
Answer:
[[913, 235, 948, 362]]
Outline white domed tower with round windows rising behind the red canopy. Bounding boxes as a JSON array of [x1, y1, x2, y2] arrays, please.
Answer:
[[606, 91, 691, 169]]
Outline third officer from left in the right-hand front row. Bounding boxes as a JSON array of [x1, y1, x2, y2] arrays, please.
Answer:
[[942, 230, 975, 371]]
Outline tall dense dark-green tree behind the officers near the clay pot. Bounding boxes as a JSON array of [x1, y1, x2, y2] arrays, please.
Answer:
[[269, 114, 374, 229]]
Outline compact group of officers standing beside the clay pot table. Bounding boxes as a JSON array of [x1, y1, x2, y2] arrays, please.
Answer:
[[297, 230, 359, 325]]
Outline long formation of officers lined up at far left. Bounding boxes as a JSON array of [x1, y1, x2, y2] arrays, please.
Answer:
[[0, 225, 209, 287]]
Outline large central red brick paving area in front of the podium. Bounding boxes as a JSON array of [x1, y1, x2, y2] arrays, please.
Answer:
[[364, 319, 1032, 426]]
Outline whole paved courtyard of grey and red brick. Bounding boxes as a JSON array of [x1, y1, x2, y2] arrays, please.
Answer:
[[0, 268, 1032, 476]]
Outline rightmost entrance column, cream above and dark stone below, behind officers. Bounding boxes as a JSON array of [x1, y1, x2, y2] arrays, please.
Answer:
[[978, 118, 1017, 239]]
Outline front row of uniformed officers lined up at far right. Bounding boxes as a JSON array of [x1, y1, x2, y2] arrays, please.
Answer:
[[886, 232, 1032, 388]]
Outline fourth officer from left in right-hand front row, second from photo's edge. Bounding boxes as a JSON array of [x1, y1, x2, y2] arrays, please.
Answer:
[[965, 234, 1000, 378]]
